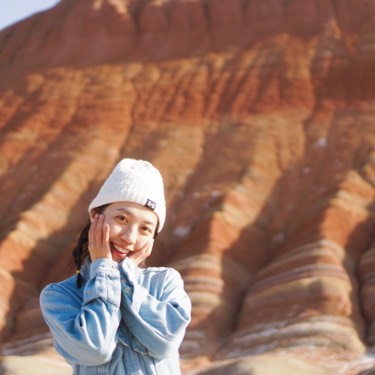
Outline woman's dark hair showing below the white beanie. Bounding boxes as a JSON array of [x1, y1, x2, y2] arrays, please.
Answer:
[[72, 204, 159, 288]]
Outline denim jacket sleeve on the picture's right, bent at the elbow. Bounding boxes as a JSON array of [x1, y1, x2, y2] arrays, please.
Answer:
[[121, 259, 191, 359]]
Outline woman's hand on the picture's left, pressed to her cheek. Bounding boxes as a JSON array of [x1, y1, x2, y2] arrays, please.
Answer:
[[89, 214, 112, 261]]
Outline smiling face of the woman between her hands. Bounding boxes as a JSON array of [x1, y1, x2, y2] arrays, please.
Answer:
[[99, 202, 158, 262]]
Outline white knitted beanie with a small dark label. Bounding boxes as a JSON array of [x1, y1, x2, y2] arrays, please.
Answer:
[[89, 159, 166, 232]]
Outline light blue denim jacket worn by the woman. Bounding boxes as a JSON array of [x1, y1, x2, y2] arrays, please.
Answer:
[[40, 259, 191, 375]]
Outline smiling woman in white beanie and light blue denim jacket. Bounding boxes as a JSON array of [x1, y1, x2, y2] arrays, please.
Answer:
[[40, 159, 191, 375]]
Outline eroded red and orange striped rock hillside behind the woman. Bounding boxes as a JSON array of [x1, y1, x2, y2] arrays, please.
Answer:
[[0, 0, 375, 375]]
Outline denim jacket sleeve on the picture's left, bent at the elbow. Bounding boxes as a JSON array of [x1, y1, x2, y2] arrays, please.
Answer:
[[40, 259, 121, 366]]
